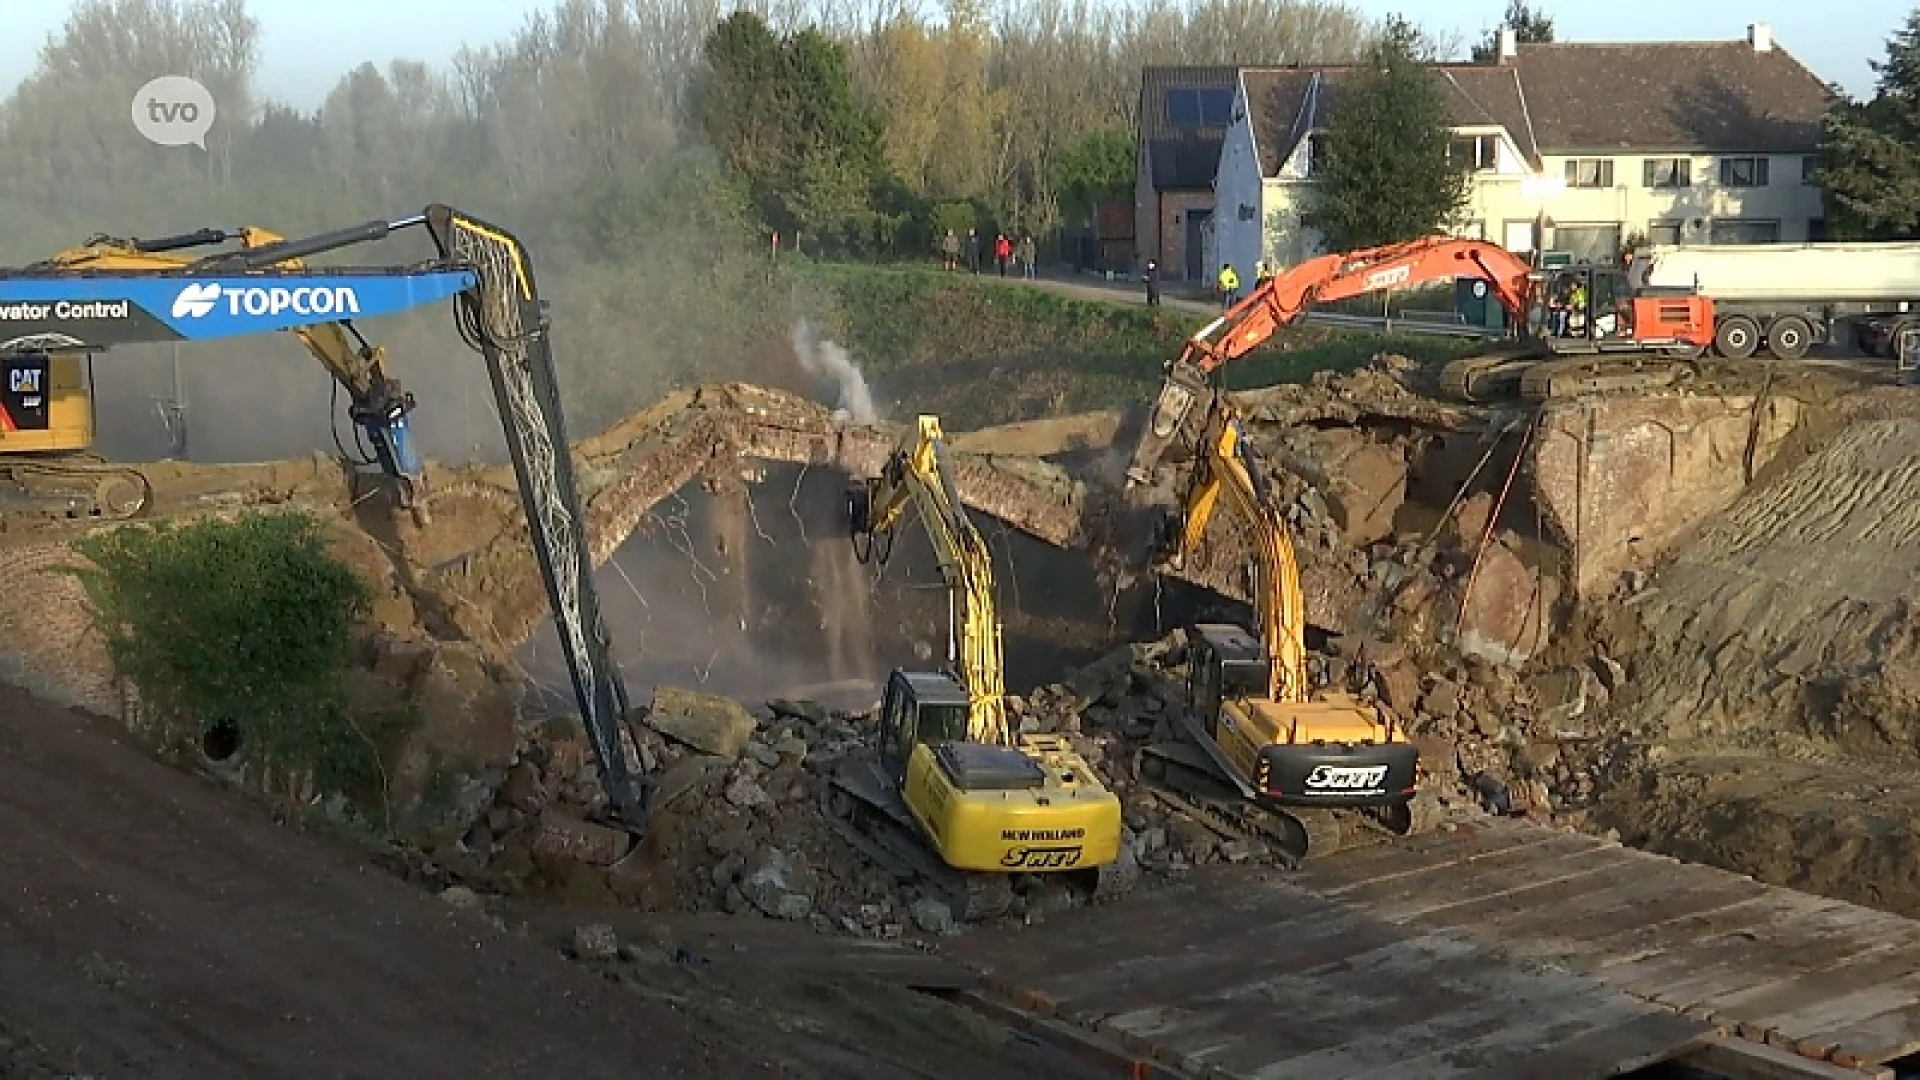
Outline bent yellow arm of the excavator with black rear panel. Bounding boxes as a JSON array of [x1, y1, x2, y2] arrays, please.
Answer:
[[1169, 402, 1308, 701]]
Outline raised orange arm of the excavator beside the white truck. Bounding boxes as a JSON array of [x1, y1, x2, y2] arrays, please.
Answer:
[[1127, 236, 1532, 488]]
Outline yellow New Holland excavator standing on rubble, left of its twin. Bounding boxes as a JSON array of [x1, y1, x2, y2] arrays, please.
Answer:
[[826, 415, 1133, 922]]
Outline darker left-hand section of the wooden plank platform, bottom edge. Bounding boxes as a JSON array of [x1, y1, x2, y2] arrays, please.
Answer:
[[945, 871, 1713, 1080]]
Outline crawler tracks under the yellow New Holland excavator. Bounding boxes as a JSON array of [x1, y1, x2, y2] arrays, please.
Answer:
[[822, 763, 1014, 922]]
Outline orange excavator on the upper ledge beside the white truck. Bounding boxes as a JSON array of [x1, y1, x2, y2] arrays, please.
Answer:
[[1127, 236, 1713, 488]]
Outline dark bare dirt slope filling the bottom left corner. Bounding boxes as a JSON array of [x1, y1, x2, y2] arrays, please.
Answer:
[[0, 686, 795, 1080]]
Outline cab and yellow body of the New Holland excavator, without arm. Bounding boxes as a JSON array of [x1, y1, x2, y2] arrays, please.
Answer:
[[879, 671, 1121, 872]]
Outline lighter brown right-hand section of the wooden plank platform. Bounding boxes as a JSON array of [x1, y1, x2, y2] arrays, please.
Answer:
[[1288, 821, 1920, 1065]]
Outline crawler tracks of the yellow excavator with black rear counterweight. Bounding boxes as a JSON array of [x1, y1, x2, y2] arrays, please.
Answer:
[[1133, 742, 1419, 869]]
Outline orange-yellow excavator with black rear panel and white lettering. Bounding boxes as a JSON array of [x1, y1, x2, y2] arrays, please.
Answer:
[[1135, 394, 1421, 863]]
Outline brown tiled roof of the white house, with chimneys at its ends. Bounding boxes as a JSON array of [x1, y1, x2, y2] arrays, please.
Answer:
[[1511, 40, 1830, 154]]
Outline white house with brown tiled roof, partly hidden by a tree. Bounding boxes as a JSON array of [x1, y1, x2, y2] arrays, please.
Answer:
[[1212, 23, 1830, 279]]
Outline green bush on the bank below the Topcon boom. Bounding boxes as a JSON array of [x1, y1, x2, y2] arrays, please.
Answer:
[[75, 513, 401, 798]]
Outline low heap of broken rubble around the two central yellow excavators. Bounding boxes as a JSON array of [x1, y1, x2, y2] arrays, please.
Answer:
[[416, 607, 1605, 938]]
